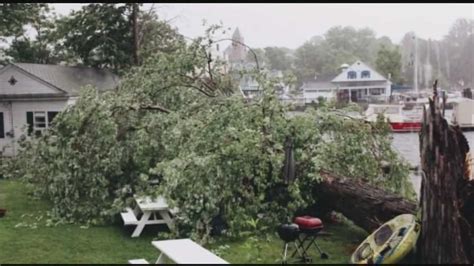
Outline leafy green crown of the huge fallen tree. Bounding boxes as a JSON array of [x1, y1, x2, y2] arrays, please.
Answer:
[[3, 25, 414, 243]]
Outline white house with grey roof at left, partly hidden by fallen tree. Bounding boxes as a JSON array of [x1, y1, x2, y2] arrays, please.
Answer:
[[0, 63, 119, 156]]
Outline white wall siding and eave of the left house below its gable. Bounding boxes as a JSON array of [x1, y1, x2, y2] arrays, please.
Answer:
[[0, 100, 66, 156]]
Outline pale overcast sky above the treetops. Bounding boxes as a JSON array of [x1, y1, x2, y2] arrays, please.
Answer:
[[52, 4, 474, 48]]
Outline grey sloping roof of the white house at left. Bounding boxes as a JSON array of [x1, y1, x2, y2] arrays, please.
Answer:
[[12, 63, 119, 96]]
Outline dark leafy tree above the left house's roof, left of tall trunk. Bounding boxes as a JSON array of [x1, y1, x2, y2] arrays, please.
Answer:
[[56, 4, 134, 72]]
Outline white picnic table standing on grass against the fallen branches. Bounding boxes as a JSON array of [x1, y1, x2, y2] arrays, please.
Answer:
[[120, 196, 177, 237]]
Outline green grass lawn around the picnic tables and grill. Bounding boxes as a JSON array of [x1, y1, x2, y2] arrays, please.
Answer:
[[0, 180, 366, 264]]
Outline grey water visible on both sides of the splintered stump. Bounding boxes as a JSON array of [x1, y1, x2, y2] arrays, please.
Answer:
[[392, 131, 474, 195]]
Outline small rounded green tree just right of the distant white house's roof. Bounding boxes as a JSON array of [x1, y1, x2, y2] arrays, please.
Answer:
[[375, 45, 403, 83]]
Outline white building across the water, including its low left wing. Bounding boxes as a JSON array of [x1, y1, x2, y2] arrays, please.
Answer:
[[301, 60, 392, 103]]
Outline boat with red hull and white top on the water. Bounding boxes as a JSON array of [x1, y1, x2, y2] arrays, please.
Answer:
[[365, 104, 423, 132]]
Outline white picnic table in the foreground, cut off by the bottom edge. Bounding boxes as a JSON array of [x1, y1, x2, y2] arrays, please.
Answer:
[[128, 239, 229, 264]]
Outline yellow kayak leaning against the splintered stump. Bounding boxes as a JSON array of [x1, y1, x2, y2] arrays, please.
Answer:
[[350, 214, 420, 264]]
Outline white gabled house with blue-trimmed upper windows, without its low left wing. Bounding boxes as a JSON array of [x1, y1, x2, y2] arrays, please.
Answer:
[[332, 60, 392, 102]]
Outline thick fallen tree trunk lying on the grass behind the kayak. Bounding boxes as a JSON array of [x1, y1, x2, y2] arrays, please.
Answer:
[[314, 172, 416, 232]]
